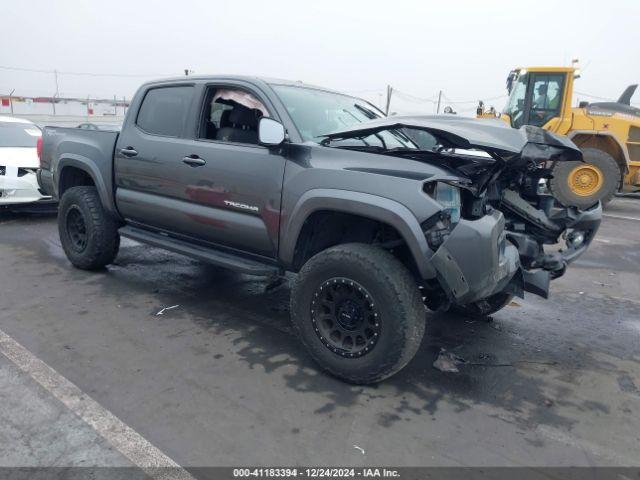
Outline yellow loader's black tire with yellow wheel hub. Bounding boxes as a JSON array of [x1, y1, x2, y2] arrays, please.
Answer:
[[549, 148, 622, 208]]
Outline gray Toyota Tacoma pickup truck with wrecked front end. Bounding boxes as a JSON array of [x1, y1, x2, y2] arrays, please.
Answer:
[[38, 76, 601, 383]]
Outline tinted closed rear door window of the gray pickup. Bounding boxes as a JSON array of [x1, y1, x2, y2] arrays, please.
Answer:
[[136, 86, 193, 137]]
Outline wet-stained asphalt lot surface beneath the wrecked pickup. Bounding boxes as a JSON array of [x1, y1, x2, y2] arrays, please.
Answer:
[[0, 198, 640, 466]]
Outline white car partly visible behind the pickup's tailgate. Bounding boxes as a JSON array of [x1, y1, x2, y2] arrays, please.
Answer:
[[0, 116, 51, 207]]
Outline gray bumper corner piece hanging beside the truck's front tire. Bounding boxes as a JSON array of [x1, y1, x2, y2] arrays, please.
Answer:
[[430, 210, 520, 305]]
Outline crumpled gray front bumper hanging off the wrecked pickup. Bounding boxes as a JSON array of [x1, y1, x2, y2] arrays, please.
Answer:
[[429, 200, 602, 305]]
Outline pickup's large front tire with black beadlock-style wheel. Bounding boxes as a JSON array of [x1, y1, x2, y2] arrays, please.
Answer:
[[291, 244, 426, 384]]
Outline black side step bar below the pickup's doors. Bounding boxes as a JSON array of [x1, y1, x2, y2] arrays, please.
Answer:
[[118, 225, 278, 275]]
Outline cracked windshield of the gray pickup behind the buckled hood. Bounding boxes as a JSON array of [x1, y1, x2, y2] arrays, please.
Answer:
[[273, 85, 415, 148]]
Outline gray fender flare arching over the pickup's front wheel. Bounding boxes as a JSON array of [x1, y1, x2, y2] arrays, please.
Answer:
[[279, 188, 436, 279]]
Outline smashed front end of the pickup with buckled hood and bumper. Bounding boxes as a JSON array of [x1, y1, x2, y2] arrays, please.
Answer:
[[327, 117, 602, 307]]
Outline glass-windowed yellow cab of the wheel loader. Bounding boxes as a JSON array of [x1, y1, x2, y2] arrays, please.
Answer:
[[502, 69, 573, 131]]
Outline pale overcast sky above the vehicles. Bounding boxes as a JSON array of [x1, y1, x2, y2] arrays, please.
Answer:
[[0, 0, 640, 115]]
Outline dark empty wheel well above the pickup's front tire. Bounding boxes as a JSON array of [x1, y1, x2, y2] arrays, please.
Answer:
[[293, 210, 418, 274]]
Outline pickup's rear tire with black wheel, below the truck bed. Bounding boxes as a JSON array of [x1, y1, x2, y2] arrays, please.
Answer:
[[58, 187, 120, 270]]
